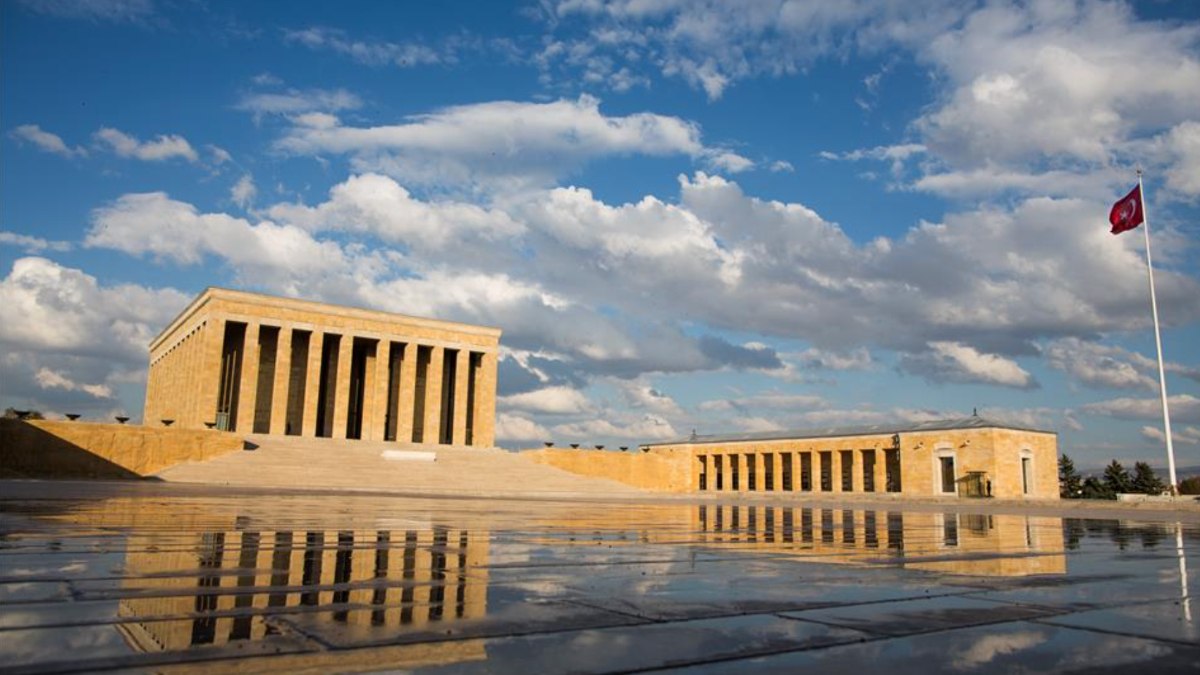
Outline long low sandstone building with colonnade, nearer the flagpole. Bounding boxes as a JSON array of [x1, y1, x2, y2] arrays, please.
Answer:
[[644, 417, 1058, 498]]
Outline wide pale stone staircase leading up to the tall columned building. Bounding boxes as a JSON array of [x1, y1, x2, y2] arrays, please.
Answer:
[[156, 435, 646, 497]]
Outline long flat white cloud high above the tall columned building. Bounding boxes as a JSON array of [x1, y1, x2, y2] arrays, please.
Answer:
[[276, 96, 710, 187]]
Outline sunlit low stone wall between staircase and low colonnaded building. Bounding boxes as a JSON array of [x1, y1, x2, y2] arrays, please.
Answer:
[[521, 448, 691, 492]]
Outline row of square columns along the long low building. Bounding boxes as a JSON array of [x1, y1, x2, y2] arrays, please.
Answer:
[[695, 448, 901, 492]]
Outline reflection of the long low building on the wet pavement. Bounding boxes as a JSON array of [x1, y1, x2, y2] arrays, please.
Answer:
[[692, 504, 1067, 577]]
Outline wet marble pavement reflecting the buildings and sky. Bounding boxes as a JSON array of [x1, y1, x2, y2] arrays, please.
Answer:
[[0, 482, 1200, 673]]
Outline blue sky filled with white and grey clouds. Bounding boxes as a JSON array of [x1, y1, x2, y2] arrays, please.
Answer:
[[0, 0, 1200, 466]]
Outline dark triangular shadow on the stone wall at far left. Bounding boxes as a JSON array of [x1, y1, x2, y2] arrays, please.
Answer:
[[0, 419, 157, 480]]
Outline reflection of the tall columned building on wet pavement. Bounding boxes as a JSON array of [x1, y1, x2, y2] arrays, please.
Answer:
[[118, 527, 488, 651]]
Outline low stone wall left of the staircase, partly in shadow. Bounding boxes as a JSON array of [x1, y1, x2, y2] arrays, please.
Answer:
[[0, 419, 244, 478]]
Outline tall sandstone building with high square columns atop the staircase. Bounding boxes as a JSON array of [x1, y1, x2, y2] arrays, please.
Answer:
[[144, 288, 500, 447]]
